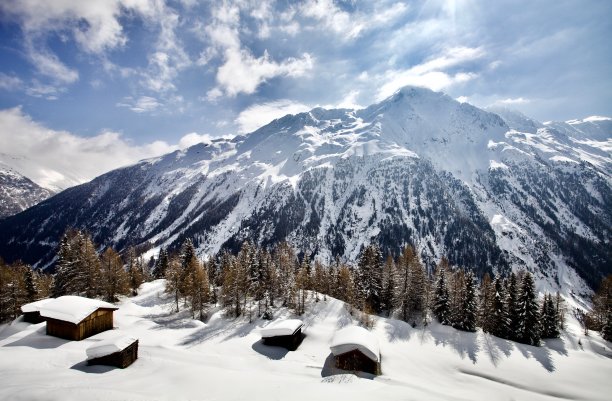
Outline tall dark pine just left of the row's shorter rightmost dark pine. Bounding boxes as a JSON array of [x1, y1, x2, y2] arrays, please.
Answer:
[[516, 272, 540, 345]]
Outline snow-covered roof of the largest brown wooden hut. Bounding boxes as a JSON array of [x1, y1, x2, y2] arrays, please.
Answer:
[[40, 295, 119, 324]]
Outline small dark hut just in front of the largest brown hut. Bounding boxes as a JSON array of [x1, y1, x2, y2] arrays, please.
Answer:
[[86, 336, 138, 369]]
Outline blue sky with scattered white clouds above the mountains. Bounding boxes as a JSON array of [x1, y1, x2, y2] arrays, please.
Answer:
[[0, 0, 612, 186]]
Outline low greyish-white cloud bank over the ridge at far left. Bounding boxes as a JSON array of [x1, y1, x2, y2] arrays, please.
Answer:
[[0, 107, 216, 190]]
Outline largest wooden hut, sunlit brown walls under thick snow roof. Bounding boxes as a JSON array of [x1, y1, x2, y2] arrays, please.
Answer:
[[40, 295, 119, 341]]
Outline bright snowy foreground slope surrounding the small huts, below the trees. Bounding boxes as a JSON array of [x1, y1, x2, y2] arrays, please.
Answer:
[[0, 280, 612, 401]]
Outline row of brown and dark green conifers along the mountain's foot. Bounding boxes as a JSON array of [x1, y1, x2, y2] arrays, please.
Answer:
[[0, 229, 612, 345]]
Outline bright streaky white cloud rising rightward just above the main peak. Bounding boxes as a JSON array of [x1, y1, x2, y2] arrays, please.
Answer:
[[376, 47, 485, 100]]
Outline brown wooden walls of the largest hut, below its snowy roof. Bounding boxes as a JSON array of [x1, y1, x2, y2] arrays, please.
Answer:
[[46, 309, 114, 341]]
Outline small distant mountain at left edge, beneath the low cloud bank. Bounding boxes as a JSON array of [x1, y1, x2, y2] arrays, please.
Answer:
[[0, 163, 53, 219]]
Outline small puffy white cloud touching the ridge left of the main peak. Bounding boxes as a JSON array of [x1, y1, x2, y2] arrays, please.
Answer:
[[234, 99, 312, 134]]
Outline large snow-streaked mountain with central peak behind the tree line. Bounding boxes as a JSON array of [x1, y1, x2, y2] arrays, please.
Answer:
[[0, 87, 612, 291]]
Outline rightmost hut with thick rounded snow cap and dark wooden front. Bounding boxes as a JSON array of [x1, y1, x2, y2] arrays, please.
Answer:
[[330, 326, 381, 375]]
